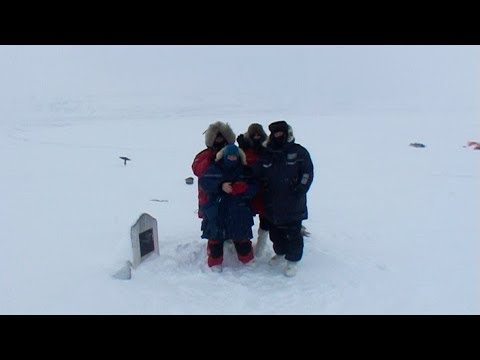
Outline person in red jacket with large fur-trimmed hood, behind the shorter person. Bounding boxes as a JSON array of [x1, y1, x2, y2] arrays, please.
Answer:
[[192, 121, 235, 219]]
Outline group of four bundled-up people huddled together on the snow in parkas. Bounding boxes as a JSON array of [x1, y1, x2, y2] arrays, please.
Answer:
[[192, 121, 313, 276]]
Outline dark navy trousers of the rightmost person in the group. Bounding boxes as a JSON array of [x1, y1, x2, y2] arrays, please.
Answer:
[[270, 221, 303, 261]]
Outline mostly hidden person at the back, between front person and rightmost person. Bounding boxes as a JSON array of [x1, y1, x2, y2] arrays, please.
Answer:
[[237, 123, 270, 257]]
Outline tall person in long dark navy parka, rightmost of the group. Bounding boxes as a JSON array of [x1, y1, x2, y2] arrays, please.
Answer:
[[255, 121, 313, 276]]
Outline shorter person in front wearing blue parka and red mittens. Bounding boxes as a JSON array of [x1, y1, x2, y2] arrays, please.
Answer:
[[199, 145, 259, 271]]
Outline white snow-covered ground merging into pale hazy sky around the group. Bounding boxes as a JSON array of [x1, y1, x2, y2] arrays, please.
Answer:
[[0, 46, 480, 314]]
